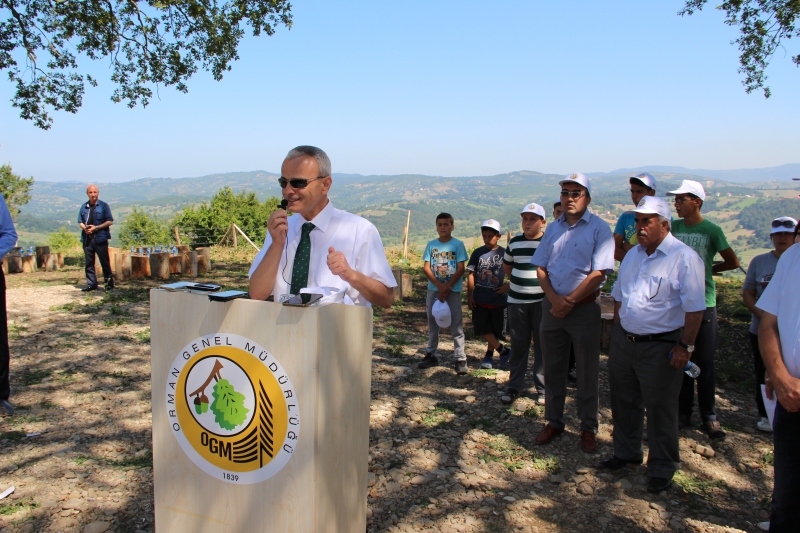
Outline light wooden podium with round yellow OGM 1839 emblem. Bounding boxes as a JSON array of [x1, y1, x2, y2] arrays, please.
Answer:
[[150, 289, 372, 533]]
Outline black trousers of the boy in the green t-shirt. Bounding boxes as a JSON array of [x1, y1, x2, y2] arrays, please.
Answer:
[[678, 307, 719, 422]]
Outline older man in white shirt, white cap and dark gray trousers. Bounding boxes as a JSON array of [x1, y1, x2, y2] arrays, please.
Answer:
[[603, 196, 706, 493]]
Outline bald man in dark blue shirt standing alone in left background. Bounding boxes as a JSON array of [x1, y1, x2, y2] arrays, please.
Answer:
[[78, 185, 114, 292]]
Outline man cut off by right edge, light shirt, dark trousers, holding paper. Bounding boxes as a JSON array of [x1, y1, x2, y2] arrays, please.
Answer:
[[756, 238, 800, 533]]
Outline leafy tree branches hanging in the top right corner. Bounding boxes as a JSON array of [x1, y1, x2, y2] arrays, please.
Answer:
[[678, 0, 800, 98]]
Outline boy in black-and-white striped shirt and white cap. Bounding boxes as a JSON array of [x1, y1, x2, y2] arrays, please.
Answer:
[[501, 203, 547, 404]]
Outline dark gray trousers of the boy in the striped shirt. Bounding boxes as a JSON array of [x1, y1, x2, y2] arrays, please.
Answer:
[[508, 302, 544, 394]]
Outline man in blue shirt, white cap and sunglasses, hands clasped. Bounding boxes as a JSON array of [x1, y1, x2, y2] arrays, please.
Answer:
[[531, 174, 614, 453]]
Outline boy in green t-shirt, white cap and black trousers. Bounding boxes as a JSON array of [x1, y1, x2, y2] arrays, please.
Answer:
[[667, 180, 739, 439]]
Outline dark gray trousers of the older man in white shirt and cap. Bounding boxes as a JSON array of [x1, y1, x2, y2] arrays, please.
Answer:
[[608, 324, 683, 478]]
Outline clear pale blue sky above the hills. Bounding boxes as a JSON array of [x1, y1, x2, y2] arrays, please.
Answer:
[[0, 0, 800, 182]]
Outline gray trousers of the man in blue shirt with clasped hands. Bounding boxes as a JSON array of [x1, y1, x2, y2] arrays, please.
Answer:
[[539, 297, 602, 433]]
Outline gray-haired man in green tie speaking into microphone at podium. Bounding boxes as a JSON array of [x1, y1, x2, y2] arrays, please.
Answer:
[[250, 146, 397, 307]]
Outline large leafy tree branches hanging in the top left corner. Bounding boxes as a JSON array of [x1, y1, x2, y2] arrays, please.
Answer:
[[0, 0, 292, 129]]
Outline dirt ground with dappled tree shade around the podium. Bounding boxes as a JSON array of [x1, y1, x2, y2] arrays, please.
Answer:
[[0, 258, 773, 533]]
